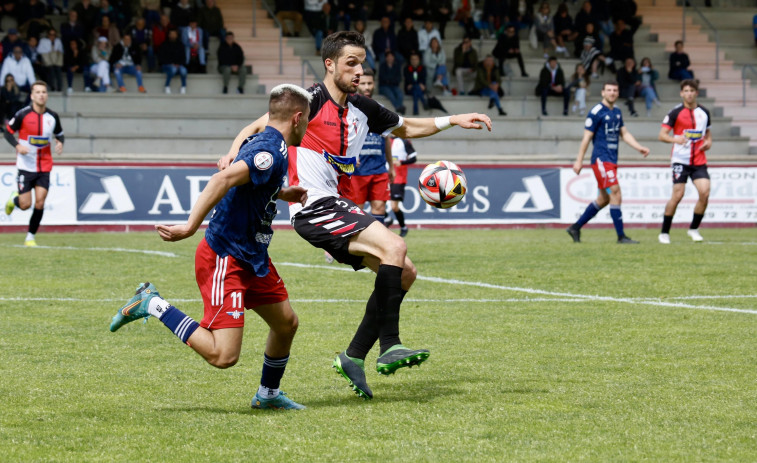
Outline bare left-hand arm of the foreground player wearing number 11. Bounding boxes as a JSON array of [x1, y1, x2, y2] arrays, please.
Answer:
[[155, 162, 250, 241]]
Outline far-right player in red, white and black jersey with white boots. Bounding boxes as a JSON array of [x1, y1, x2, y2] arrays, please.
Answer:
[[658, 80, 712, 244]]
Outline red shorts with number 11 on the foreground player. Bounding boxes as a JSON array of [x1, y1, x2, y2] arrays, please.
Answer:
[[195, 238, 289, 330]]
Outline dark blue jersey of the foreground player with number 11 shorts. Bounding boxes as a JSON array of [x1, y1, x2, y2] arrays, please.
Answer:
[[205, 126, 289, 277]]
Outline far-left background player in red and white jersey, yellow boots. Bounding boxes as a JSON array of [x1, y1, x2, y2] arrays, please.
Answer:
[[5, 81, 64, 246]]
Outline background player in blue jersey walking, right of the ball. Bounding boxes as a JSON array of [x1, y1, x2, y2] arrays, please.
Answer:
[[566, 81, 649, 244]]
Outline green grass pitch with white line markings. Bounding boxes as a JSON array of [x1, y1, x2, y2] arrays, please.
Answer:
[[0, 228, 757, 462]]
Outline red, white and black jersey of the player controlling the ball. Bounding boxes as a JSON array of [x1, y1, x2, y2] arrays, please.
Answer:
[[289, 83, 403, 217]]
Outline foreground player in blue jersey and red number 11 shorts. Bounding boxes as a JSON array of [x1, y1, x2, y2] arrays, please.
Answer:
[[110, 84, 311, 409]]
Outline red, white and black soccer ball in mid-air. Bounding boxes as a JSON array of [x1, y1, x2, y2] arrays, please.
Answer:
[[418, 161, 468, 209]]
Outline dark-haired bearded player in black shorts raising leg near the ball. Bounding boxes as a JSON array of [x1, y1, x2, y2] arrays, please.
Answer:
[[219, 31, 491, 398]]
